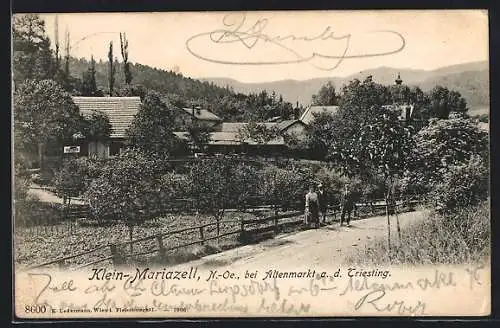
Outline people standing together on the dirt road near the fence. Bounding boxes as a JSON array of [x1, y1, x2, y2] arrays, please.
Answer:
[[304, 183, 355, 228]]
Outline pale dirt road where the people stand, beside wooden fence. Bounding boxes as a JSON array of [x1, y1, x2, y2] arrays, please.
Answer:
[[175, 212, 426, 269]]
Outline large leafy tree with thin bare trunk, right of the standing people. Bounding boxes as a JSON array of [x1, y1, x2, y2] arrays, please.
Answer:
[[327, 77, 412, 249]]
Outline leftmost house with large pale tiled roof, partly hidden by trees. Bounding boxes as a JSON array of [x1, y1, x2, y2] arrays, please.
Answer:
[[73, 97, 141, 158]]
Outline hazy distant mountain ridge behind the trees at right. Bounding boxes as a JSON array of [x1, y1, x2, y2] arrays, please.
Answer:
[[199, 61, 489, 111]]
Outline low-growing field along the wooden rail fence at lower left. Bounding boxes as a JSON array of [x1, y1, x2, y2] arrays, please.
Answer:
[[14, 211, 306, 268]]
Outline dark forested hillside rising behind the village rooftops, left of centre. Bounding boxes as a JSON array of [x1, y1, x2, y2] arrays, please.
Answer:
[[66, 58, 294, 122]]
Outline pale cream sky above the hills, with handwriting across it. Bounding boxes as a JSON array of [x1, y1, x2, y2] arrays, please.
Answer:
[[30, 10, 488, 83]]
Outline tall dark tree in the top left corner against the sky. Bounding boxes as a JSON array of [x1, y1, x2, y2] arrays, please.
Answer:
[[12, 14, 54, 85]]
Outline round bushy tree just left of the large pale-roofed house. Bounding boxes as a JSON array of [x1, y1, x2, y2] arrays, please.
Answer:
[[14, 80, 84, 168]]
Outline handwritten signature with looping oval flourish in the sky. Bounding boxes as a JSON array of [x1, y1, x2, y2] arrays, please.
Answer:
[[186, 14, 406, 71]]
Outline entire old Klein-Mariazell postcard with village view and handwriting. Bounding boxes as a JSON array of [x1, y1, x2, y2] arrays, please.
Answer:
[[11, 10, 491, 320]]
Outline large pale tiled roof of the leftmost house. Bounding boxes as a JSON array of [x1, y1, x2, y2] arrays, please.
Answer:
[[73, 97, 141, 138]]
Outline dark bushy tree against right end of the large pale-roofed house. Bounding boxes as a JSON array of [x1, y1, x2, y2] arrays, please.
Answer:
[[127, 92, 177, 155]]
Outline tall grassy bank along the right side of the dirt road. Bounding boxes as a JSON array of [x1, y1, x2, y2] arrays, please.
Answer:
[[346, 201, 491, 265]]
